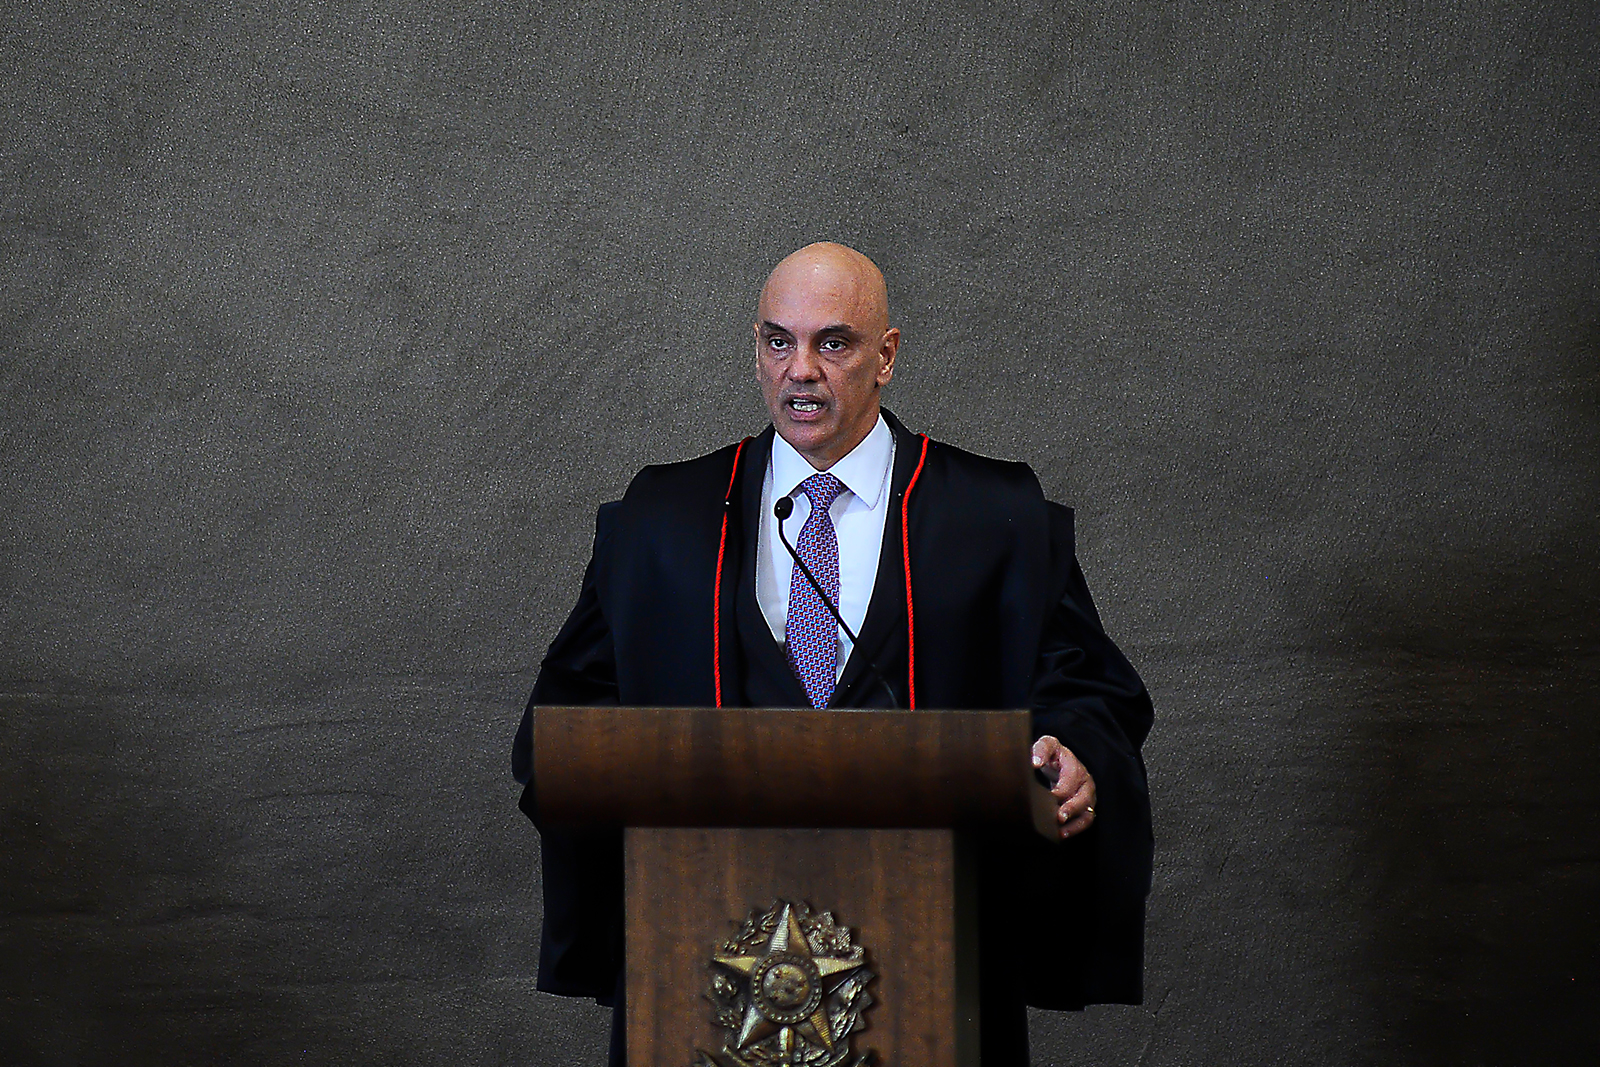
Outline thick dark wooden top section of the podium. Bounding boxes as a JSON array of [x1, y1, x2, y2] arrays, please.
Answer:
[[533, 707, 1034, 827]]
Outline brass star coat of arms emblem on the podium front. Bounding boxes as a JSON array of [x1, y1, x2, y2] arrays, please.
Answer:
[[694, 901, 874, 1067]]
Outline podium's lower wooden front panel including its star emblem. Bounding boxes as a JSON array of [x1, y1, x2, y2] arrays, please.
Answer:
[[626, 829, 978, 1067]]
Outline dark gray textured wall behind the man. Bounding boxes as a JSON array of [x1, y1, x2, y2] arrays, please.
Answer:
[[0, 0, 1600, 1067]]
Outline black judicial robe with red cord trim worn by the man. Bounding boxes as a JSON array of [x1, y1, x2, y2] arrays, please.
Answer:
[[512, 411, 1152, 1008]]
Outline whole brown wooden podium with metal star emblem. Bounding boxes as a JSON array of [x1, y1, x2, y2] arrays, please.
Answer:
[[533, 707, 1056, 1067]]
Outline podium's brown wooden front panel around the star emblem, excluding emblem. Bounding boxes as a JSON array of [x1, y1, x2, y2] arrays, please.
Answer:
[[626, 829, 978, 1067]]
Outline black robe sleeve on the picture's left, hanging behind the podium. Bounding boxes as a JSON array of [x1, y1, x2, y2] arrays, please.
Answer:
[[512, 504, 622, 1005]]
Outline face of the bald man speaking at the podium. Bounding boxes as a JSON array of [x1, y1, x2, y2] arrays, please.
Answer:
[[755, 252, 899, 470]]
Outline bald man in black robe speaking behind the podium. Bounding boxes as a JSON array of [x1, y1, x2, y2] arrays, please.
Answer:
[[512, 243, 1152, 1067]]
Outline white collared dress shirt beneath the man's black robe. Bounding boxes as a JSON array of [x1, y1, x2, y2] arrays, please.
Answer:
[[755, 414, 894, 677]]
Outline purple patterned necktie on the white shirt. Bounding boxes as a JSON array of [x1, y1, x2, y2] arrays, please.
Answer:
[[784, 474, 845, 707]]
